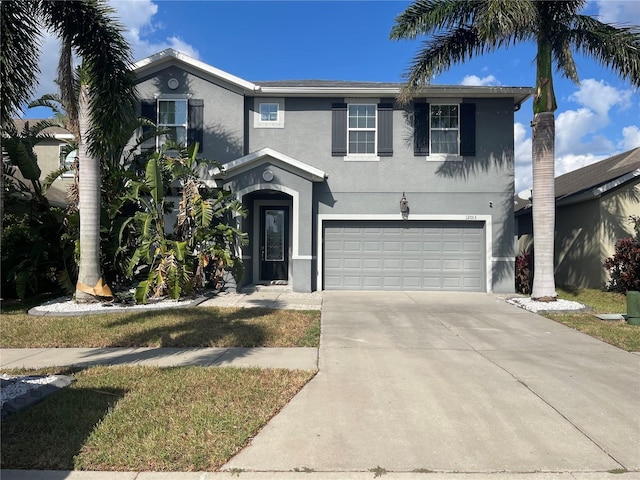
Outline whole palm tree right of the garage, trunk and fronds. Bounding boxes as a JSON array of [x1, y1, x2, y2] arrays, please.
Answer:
[[390, 0, 640, 301]]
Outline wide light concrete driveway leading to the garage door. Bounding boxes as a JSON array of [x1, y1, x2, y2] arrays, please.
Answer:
[[225, 292, 640, 473]]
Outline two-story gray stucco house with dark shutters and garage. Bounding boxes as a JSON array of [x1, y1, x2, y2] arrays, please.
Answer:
[[134, 50, 533, 292]]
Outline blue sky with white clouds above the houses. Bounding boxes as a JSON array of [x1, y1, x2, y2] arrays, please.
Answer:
[[27, 0, 640, 192]]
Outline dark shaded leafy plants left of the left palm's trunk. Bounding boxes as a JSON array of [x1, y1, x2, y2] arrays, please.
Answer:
[[2, 121, 76, 300]]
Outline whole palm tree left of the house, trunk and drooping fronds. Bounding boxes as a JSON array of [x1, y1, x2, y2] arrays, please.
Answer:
[[0, 0, 136, 301]]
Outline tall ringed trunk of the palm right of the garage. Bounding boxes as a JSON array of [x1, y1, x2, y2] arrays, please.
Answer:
[[531, 34, 558, 301]]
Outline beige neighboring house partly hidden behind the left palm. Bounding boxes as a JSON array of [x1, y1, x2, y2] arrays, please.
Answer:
[[8, 119, 74, 207]]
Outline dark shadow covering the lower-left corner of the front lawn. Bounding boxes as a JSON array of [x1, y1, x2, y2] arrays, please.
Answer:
[[0, 368, 127, 468]]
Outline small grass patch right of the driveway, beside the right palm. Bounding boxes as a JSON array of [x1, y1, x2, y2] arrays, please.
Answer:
[[541, 288, 640, 352]]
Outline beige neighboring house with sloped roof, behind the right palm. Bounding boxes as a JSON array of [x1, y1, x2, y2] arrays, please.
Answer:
[[515, 147, 640, 288]]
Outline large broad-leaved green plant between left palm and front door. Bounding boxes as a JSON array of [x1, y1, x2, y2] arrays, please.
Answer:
[[119, 144, 246, 303]]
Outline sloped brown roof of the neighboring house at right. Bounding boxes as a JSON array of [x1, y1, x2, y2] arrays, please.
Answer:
[[515, 147, 640, 211]]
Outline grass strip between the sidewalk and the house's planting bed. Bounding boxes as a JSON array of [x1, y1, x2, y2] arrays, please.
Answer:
[[0, 306, 320, 348]]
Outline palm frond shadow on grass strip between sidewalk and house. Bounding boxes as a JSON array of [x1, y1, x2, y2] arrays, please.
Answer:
[[106, 307, 273, 348]]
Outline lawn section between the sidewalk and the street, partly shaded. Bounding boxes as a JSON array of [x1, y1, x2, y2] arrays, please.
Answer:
[[0, 367, 314, 471]]
